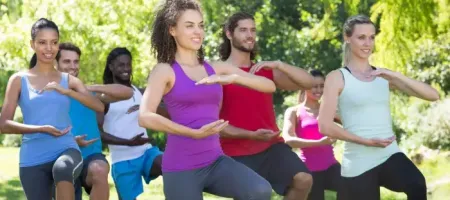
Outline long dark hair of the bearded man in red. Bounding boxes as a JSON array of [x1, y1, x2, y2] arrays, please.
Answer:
[[219, 12, 256, 61]]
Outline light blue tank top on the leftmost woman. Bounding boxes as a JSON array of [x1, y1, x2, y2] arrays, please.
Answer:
[[19, 73, 78, 167]]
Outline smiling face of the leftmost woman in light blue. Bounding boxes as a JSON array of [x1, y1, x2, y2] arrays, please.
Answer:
[[30, 28, 59, 64]]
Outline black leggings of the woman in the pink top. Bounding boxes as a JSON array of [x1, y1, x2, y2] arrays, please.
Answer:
[[308, 163, 342, 200]]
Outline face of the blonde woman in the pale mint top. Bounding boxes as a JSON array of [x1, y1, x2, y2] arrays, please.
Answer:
[[345, 24, 375, 59]]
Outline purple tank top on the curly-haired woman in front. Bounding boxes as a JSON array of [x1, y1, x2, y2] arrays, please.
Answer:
[[162, 62, 223, 172]]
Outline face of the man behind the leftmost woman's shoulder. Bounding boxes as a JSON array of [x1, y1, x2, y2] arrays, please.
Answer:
[[58, 50, 80, 77]]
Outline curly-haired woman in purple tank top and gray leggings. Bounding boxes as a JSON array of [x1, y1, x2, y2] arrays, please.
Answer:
[[139, 0, 275, 200]]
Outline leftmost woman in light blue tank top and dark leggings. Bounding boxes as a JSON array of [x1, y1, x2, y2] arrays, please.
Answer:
[[0, 18, 103, 200]]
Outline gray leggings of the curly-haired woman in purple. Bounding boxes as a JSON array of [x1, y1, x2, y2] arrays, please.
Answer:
[[163, 156, 272, 200]]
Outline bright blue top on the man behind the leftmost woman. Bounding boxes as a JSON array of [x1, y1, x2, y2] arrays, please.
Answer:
[[69, 98, 102, 159]]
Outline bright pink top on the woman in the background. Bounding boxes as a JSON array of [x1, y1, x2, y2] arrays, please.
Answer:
[[296, 106, 337, 171]]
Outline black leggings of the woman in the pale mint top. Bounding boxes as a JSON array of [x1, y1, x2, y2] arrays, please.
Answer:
[[338, 153, 427, 200]]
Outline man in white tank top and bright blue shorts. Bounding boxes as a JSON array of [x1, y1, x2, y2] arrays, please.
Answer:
[[97, 48, 169, 200]]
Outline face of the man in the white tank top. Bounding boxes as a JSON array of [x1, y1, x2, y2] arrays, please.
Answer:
[[109, 55, 132, 81]]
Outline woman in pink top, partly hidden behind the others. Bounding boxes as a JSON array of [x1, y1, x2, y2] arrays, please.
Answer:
[[283, 70, 341, 200]]
